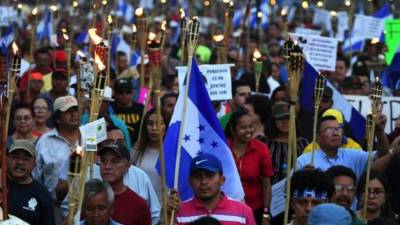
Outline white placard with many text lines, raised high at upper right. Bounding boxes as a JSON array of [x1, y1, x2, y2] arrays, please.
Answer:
[[290, 33, 338, 71]]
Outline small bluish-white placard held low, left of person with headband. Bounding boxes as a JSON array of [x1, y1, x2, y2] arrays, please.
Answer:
[[271, 179, 286, 217]]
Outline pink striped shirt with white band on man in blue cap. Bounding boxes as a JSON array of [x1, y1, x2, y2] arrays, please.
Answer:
[[176, 194, 256, 225]]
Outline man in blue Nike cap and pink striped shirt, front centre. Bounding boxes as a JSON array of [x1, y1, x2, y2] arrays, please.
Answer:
[[168, 153, 256, 225]]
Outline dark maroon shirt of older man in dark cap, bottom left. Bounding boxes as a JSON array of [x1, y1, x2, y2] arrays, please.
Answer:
[[111, 188, 151, 225]]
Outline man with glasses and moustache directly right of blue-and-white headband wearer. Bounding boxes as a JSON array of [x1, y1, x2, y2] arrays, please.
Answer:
[[326, 165, 365, 225]]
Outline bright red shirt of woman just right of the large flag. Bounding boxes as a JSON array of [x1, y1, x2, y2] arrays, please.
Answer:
[[228, 138, 274, 210]]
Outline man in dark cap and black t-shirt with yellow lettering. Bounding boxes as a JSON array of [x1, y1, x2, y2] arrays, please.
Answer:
[[111, 79, 143, 144]]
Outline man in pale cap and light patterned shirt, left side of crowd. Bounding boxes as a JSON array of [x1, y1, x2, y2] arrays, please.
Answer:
[[33, 96, 80, 200]]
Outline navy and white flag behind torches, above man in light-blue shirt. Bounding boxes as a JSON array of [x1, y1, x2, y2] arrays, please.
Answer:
[[300, 62, 365, 142]]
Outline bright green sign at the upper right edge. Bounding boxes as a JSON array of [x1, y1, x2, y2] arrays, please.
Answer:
[[385, 19, 400, 65]]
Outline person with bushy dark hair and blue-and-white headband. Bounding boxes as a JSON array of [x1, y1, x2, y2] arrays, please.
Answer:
[[289, 170, 333, 225]]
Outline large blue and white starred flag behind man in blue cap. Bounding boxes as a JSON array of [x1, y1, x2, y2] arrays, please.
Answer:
[[164, 60, 244, 200]]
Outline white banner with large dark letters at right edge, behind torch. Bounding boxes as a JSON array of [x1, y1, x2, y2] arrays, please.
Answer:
[[344, 95, 400, 133]]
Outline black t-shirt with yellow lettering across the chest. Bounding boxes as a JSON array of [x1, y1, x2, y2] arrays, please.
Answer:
[[111, 102, 144, 145]]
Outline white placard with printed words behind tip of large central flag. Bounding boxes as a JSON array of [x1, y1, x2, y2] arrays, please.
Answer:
[[176, 64, 234, 101]]
